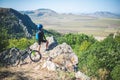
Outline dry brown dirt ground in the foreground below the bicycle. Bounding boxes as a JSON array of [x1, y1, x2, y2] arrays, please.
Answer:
[[0, 62, 75, 80]]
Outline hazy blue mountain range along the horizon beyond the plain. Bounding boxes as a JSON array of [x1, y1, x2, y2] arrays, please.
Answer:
[[20, 9, 120, 18]]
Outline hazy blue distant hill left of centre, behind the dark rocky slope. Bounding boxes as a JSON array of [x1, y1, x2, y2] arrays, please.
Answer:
[[20, 9, 57, 16]]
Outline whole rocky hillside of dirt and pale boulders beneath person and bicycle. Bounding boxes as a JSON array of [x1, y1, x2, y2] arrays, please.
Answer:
[[0, 37, 90, 80]]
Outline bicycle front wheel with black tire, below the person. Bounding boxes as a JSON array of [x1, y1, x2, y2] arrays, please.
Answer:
[[29, 50, 42, 62]]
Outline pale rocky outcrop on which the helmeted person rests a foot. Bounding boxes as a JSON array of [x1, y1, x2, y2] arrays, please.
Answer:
[[30, 37, 78, 71]]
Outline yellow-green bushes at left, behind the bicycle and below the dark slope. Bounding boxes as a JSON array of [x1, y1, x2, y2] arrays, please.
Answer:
[[0, 27, 35, 52]]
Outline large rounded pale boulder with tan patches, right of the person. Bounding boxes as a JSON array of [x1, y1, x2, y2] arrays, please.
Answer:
[[49, 43, 78, 71]]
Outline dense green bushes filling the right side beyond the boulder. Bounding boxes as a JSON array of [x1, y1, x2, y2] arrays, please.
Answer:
[[58, 33, 120, 80]]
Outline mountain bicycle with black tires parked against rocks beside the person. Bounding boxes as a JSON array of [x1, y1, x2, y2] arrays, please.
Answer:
[[6, 47, 42, 66]]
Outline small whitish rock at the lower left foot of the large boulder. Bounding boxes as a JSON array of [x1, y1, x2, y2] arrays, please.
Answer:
[[42, 61, 56, 71]]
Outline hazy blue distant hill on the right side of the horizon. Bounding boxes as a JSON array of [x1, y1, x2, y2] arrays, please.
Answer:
[[81, 11, 120, 18]]
